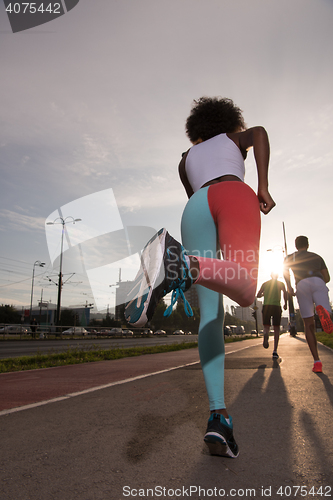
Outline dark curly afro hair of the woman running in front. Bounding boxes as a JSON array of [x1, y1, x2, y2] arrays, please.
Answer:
[[186, 97, 246, 143]]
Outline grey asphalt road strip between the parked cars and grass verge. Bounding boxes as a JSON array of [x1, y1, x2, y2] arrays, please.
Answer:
[[0, 335, 198, 359]]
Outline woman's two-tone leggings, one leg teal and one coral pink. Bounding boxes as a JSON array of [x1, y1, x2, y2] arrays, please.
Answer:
[[181, 182, 260, 410]]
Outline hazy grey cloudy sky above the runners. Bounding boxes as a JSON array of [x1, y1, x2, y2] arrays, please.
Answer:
[[0, 0, 333, 311]]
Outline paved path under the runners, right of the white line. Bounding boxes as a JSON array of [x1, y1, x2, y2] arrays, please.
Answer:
[[0, 335, 333, 500]]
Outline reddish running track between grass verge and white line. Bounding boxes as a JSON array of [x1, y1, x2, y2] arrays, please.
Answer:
[[0, 349, 199, 411]]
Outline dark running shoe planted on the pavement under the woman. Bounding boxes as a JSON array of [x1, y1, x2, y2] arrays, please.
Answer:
[[204, 413, 239, 458]]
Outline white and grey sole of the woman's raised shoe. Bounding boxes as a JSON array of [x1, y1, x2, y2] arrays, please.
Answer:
[[125, 229, 167, 327]]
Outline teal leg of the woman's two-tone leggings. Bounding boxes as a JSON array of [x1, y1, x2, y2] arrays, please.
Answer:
[[181, 187, 225, 410]]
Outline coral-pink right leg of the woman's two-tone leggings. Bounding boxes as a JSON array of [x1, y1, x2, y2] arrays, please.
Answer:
[[189, 181, 260, 307]]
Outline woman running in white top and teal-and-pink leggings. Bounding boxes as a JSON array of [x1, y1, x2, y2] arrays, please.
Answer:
[[125, 97, 275, 458]]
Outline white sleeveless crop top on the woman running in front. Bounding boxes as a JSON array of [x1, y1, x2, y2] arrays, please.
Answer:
[[185, 134, 245, 192]]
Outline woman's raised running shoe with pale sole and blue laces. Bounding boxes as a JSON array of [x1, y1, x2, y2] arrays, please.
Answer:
[[125, 229, 194, 327]]
